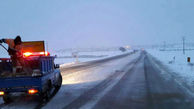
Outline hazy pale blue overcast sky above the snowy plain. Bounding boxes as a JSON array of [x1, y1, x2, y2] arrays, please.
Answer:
[[0, 0, 194, 49]]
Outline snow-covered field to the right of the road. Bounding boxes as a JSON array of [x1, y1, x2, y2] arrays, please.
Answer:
[[147, 49, 194, 88]]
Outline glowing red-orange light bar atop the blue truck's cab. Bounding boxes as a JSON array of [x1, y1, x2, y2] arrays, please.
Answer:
[[23, 51, 50, 57]]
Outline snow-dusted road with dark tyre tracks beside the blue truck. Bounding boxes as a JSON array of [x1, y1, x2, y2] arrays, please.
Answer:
[[0, 52, 194, 109]]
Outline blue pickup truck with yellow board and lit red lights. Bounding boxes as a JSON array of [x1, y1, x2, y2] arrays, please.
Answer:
[[0, 41, 62, 103]]
